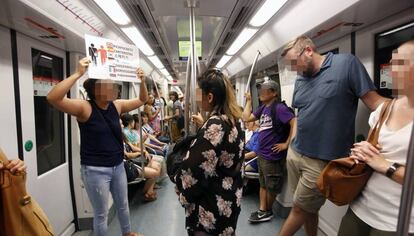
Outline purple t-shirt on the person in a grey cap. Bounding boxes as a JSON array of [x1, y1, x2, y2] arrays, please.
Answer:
[[253, 103, 295, 161]]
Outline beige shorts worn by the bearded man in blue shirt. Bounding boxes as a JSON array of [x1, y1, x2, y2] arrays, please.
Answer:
[[286, 147, 328, 213]]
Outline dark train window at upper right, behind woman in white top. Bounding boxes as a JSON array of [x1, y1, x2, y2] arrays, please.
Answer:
[[374, 22, 414, 97]]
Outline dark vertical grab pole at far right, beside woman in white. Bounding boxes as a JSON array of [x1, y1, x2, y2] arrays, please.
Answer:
[[397, 124, 414, 236]]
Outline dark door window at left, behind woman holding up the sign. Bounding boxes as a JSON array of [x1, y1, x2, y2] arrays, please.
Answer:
[[32, 49, 65, 175]]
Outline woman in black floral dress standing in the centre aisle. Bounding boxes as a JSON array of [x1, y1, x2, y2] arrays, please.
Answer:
[[175, 70, 244, 236]]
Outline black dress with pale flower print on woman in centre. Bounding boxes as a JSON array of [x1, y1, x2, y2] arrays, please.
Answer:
[[175, 115, 244, 236]]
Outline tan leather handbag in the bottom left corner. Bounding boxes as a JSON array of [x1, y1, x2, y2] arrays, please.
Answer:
[[0, 149, 53, 236]]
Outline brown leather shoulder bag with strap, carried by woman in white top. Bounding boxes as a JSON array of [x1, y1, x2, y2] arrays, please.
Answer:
[[316, 98, 391, 206]]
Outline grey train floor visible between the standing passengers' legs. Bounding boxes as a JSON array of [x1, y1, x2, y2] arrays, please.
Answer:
[[75, 179, 312, 236]]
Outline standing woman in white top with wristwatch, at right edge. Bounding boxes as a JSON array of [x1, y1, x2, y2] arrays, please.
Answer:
[[339, 40, 414, 236]]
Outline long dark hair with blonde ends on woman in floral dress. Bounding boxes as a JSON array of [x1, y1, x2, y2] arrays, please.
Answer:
[[198, 69, 242, 125]]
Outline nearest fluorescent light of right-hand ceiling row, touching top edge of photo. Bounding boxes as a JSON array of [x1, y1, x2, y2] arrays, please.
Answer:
[[249, 0, 287, 27]]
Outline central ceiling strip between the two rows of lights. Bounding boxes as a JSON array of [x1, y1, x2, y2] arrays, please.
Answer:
[[119, 0, 263, 80]]
